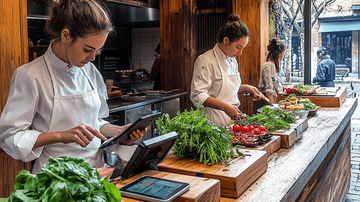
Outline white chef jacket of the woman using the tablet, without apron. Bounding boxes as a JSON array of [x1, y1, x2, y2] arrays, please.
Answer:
[[0, 45, 109, 162]]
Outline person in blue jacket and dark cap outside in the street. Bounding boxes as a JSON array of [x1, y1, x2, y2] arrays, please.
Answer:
[[313, 47, 335, 87]]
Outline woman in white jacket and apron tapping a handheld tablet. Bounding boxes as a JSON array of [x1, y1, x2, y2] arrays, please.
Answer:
[[0, 0, 143, 177]]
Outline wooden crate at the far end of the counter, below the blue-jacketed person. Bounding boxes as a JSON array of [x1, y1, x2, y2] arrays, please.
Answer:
[[281, 87, 347, 107]]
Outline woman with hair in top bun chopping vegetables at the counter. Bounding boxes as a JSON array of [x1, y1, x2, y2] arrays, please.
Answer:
[[190, 14, 264, 126]]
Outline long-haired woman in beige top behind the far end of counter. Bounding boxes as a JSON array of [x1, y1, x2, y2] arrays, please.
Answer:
[[254, 39, 285, 109]]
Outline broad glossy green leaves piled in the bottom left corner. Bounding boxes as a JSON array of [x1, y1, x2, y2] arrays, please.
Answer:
[[0, 157, 121, 202]]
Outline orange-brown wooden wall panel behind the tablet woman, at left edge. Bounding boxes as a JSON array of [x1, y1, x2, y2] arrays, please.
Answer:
[[0, 0, 30, 198]]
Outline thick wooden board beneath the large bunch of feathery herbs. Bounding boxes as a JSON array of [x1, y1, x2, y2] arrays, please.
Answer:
[[158, 148, 268, 198]]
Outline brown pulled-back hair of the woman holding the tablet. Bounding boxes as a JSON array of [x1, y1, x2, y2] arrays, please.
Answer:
[[46, 0, 114, 42]]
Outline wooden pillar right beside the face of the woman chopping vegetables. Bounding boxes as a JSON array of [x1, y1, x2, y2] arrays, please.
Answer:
[[232, 0, 269, 114]]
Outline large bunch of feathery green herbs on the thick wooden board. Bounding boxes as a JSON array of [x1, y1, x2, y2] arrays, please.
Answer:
[[156, 103, 234, 165]]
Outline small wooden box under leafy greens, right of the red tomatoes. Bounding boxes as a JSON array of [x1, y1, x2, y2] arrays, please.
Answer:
[[272, 119, 308, 148]]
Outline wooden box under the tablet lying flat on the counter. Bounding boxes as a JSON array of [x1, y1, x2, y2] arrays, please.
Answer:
[[114, 170, 220, 202]]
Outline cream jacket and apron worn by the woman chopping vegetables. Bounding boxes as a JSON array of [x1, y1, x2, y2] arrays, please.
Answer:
[[190, 44, 241, 126]]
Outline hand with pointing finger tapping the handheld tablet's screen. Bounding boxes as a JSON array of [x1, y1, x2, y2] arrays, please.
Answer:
[[59, 124, 106, 147]]
